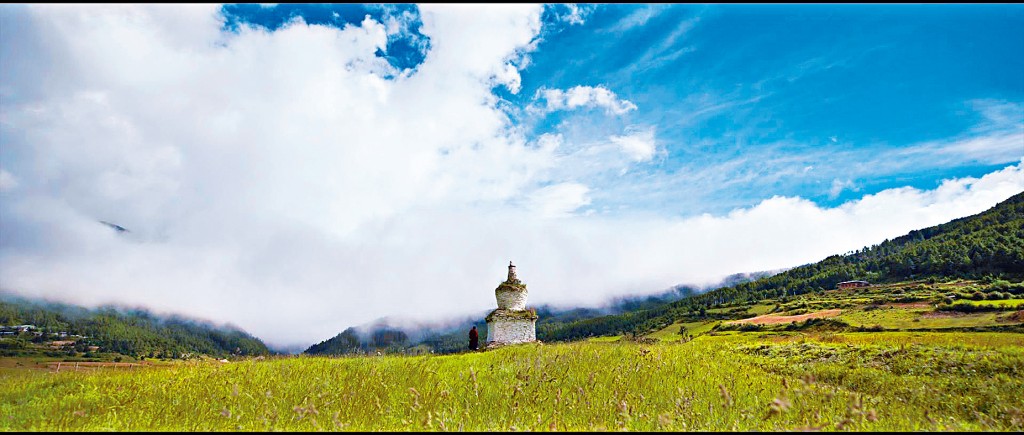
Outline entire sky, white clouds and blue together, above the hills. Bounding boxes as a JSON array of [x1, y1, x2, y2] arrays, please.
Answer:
[[0, 4, 1024, 347]]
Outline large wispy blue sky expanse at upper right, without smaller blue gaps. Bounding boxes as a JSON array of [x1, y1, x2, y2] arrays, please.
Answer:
[[523, 5, 1024, 206]]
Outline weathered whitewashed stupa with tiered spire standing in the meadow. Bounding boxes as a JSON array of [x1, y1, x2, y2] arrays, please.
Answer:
[[486, 261, 537, 347]]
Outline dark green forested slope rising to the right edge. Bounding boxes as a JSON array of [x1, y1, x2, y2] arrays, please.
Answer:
[[538, 192, 1024, 341]]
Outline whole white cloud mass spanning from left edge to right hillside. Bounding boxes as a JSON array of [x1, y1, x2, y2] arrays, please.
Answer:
[[0, 5, 1024, 346]]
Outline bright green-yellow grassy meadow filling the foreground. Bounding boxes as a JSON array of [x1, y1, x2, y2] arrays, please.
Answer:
[[0, 327, 1024, 431]]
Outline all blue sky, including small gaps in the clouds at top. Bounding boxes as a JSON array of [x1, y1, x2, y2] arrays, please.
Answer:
[[223, 4, 1024, 216]]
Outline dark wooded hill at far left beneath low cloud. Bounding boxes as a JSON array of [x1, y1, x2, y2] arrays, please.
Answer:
[[0, 293, 272, 358]]
